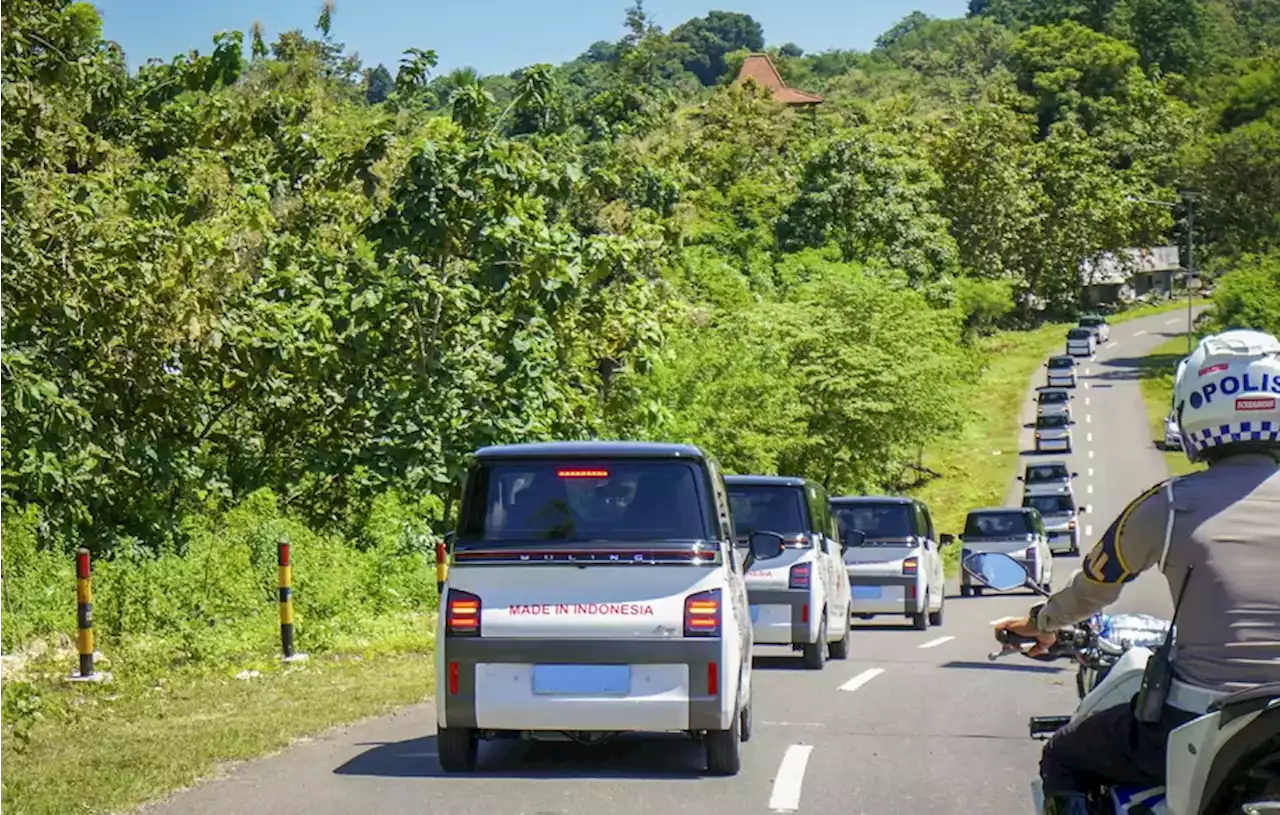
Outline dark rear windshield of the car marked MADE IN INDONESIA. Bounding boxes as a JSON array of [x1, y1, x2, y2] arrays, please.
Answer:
[[458, 459, 712, 542]]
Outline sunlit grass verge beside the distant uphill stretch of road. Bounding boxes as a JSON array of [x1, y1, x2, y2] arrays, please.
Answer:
[[911, 294, 1208, 574]]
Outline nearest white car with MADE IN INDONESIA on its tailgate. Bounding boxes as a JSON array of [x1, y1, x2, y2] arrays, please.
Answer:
[[435, 441, 757, 775]]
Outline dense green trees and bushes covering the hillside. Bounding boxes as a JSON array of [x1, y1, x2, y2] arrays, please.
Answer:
[[0, 0, 1280, 653]]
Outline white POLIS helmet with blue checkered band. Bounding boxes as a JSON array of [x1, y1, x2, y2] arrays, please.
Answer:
[[1174, 330, 1280, 462]]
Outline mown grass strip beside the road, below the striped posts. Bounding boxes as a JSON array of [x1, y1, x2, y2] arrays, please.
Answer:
[[0, 632, 434, 815]]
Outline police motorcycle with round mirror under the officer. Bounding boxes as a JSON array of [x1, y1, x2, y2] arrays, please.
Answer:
[[961, 553, 1280, 815]]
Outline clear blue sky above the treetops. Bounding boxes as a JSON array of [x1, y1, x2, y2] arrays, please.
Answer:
[[93, 0, 968, 73]]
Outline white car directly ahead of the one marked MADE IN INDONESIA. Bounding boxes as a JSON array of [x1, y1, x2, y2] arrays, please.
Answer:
[[724, 476, 850, 669]]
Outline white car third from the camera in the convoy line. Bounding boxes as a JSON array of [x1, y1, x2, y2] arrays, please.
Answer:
[[831, 495, 952, 631]]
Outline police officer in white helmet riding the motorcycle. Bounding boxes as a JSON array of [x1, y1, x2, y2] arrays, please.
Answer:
[[996, 331, 1280, 815]]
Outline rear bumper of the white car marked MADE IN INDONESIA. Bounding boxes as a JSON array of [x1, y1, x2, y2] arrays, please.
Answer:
[[436, 637, 736, 732]]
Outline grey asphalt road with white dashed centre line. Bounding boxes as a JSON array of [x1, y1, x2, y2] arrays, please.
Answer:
[[140, 313, 1185, 815]]
